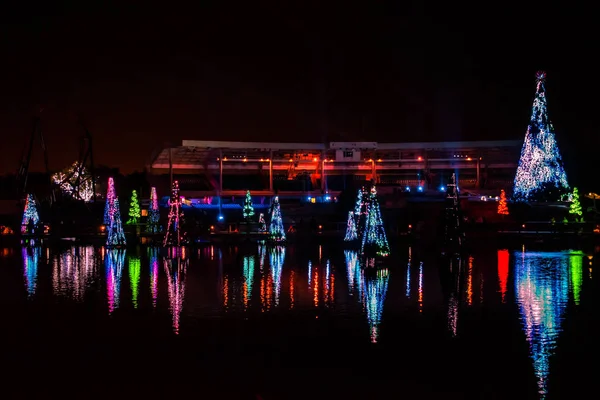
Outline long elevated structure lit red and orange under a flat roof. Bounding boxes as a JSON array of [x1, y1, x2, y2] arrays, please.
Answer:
[[149, 140, 522, 202]]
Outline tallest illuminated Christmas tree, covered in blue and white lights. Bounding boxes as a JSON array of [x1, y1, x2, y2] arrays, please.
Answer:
[[513, 71, 569, 201]]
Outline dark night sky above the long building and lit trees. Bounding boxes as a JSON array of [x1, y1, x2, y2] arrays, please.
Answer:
[[0, 1, 600, 184]]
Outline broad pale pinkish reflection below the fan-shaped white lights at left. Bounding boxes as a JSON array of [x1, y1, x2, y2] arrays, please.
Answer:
[[52, 246, 96, 301]]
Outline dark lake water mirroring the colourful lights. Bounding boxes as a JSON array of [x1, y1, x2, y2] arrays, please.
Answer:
[[0, 245, 598, 400]]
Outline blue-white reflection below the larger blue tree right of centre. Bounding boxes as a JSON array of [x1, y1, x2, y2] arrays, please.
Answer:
[[365, 269, 390, 343]]
